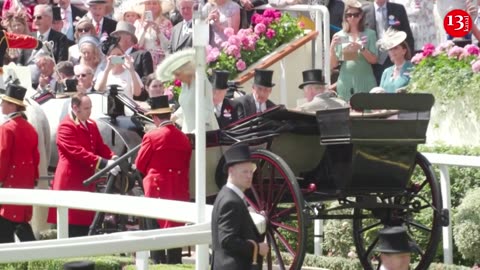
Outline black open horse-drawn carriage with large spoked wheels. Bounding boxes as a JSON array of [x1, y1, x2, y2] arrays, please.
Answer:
[[81, 89, 449, 269]]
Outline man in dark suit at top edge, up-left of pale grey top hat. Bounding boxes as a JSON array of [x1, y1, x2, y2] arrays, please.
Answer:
[[86, 0, 117, 39]]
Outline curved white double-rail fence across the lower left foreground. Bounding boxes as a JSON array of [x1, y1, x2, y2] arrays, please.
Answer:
[[0, 188, 266, 269]]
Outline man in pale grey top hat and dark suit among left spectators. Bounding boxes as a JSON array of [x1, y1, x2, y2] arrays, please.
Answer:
[[111, 21, 153, 79]]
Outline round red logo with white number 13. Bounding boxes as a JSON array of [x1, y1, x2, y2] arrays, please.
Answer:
[[443, 9, 473, 37]]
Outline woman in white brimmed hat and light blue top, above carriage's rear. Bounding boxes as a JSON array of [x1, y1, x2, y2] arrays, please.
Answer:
[[377, 28, 413, 93]]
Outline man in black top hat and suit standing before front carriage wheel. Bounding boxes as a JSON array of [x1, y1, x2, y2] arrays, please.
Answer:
[[212, 143, 269, 270]]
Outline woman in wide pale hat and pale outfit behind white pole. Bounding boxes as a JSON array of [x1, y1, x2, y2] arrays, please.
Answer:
[[156, 49, 218, 133]]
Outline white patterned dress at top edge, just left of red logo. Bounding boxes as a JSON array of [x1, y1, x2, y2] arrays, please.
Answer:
[[390, 0, 438, 51]]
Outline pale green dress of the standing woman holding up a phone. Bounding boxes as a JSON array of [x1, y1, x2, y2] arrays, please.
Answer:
[[335, 29, 378, 102]]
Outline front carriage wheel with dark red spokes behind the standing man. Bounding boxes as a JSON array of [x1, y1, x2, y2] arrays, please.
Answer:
[[246, 149, 306, 270]]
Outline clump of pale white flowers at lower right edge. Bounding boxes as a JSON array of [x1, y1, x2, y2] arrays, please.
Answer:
[[452, 188, 480, 262]]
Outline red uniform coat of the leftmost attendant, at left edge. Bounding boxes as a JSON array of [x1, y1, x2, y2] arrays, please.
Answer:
[[0, 114, 40, 223]]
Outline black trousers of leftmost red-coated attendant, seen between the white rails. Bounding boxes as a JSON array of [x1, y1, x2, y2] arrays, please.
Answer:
[[0, 216, 36, 244]]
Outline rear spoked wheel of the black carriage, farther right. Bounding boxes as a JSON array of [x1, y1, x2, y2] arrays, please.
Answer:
[[353, 153, 442, 270]]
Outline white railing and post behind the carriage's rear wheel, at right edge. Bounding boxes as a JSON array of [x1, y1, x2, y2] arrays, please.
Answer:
[[422, 153, 480, 264]]
